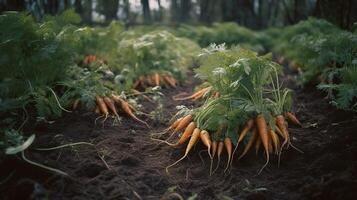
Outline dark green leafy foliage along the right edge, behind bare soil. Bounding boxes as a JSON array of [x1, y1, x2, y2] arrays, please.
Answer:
[[265, 18, 357, 110]]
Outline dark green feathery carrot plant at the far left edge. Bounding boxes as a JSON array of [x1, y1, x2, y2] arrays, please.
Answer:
[[0, 12, 76, 175]]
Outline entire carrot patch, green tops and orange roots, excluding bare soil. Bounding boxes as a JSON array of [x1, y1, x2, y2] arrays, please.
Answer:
[[0, 11, 357, 198]]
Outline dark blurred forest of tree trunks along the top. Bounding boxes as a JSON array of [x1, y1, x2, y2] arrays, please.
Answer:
[[0, 0, 357, 29]]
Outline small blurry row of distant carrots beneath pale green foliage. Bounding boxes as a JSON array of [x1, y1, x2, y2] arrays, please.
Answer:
[[133, 73, 177, 88]]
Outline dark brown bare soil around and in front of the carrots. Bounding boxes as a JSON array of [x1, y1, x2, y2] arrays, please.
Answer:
[[0, 71, 357, 200]]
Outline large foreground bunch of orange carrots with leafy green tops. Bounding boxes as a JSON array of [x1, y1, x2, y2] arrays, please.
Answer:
[[154, 45, 301, 174]]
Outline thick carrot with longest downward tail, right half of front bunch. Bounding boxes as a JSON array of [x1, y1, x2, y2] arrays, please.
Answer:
[[255, 114, 269, 174]]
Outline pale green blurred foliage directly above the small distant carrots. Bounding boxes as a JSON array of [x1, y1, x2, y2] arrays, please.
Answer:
[[115, 31, 199, 87]]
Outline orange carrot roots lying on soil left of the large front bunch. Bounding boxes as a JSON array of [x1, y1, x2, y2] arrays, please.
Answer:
[[72, 94, 149, 127]]
